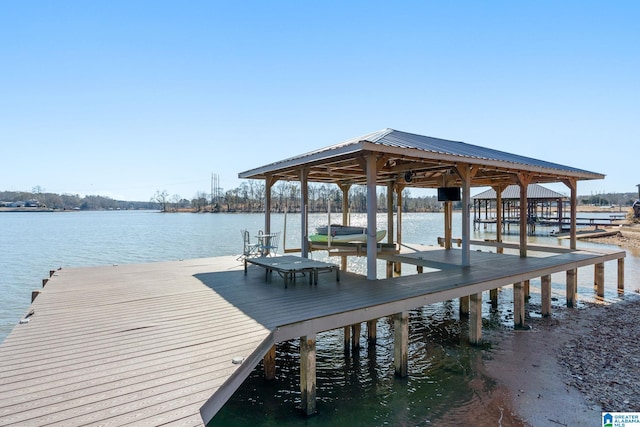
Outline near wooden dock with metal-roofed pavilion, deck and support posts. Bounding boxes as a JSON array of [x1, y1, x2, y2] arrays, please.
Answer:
[[0, 129, 625, 425]]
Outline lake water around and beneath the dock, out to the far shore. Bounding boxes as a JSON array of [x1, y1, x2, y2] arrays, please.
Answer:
[[0, 211, 640, 426]]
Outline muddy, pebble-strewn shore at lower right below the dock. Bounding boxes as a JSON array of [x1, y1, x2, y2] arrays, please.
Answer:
[[485, 294, 640, 426]]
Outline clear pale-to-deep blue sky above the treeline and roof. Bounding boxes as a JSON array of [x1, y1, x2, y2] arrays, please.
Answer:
[[0, 0, 640, 200]]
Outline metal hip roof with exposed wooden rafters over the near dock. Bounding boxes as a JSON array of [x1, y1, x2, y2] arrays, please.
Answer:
[[238, 129, 604, 188]]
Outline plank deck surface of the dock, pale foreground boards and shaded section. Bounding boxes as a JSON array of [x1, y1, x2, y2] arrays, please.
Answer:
[[0, 249, 624, 426]]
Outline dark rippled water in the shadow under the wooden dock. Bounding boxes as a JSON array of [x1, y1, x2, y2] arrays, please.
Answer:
[[209, 302, 525, 427]]
